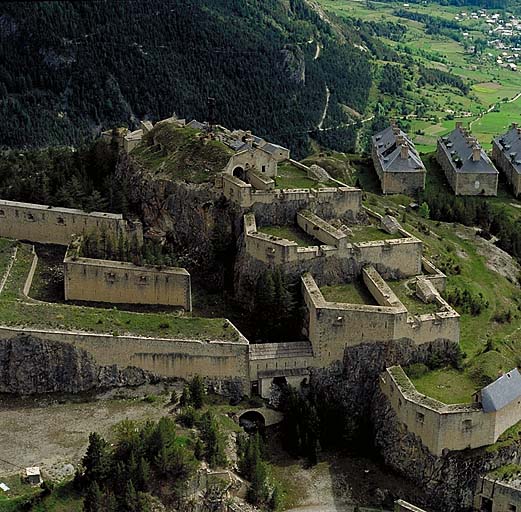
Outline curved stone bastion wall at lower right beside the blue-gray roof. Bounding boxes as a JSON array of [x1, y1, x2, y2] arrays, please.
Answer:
[[380, 366, 521, 456]]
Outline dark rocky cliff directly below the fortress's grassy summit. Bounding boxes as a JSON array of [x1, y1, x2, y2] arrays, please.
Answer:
[[117, 154, 240, 286]]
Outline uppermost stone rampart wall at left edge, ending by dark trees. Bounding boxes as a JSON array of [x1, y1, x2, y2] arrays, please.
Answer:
[[0, 200, 129, 245]]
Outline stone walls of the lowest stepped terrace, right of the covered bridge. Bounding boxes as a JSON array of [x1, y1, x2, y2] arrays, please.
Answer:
[[302, 266, 459, 365]]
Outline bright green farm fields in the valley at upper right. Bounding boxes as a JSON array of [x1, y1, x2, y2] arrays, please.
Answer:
[[319, 0, 521, 153]]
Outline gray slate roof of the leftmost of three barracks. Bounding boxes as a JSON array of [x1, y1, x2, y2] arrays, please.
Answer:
[[372, 126, 425, 172]]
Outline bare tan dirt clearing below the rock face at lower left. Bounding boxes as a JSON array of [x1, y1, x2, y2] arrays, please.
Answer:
[[0, 392, 168, 478]]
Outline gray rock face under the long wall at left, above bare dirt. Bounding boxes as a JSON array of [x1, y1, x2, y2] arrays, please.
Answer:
[[0, 334, 158, 395]]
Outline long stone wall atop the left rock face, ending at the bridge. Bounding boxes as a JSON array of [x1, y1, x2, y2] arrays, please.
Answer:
[[0, 327, 249, 384]]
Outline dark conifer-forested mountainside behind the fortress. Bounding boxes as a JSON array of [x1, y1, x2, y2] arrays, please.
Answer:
[[0, 0, 371, 154]]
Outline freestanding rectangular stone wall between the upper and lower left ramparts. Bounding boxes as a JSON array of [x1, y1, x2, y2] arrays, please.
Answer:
[[64, 256, 192, 311]]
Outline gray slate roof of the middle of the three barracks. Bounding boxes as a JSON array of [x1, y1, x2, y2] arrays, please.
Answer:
[[438, 127, 498, 174]]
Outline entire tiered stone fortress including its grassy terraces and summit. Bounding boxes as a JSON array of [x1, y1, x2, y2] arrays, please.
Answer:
[[0, 117, 521, 512]]
